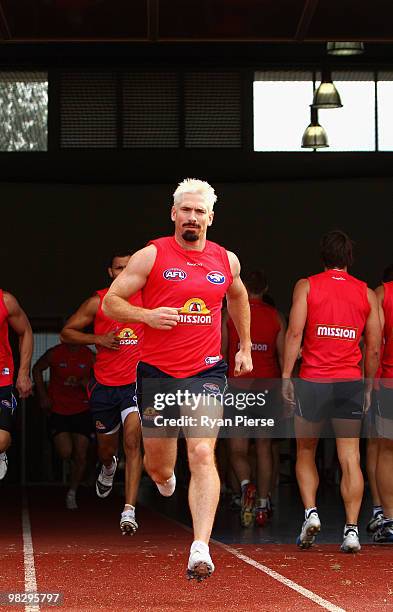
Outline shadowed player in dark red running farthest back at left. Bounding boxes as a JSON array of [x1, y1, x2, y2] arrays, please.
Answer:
[[33, 344, 94, 510]]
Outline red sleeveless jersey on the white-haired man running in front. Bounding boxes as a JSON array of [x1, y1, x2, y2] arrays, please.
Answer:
[[141, 236, 233, 378]]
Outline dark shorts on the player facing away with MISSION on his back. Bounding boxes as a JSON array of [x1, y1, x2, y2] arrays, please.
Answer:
[[295, 378, 364, 423]]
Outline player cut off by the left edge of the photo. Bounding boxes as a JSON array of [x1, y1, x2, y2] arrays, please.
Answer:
[[0, 289, 33, 480]]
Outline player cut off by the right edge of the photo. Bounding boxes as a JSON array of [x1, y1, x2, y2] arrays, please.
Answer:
[[373, 266, 393, 543]]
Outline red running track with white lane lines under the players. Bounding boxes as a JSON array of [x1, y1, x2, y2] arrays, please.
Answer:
[[0, 488, 393, 612]]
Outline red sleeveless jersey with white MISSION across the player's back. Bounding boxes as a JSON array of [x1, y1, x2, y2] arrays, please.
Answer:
[[300, 270, 370, 382]]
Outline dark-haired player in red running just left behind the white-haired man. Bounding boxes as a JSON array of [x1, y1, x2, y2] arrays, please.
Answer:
[[61, 253, 143, 535]]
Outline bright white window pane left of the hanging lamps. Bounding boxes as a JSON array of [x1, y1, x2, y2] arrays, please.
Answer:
[[254, 75, 313, 151]]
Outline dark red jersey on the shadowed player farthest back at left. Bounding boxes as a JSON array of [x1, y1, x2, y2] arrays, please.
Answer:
[[48, 344, 94, 415]]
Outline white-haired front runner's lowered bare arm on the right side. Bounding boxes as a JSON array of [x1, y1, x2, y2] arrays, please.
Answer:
[[227, 251, 252, 376]]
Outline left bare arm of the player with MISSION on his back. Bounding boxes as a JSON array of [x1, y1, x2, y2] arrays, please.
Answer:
[[282, 278, 310, 378]]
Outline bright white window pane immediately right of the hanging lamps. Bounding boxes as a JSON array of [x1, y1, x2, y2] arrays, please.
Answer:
[[317, 80, 375, 152]]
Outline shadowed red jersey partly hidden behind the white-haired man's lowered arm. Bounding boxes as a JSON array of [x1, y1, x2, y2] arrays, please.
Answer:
[[227, 298, 281, 378]]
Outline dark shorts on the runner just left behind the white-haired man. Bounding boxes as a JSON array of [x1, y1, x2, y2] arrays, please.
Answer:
[[87, 376, 138, 434]]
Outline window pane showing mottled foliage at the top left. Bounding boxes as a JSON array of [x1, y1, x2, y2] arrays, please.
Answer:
[[0, 72, 48, 151]]
